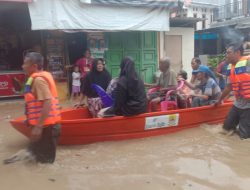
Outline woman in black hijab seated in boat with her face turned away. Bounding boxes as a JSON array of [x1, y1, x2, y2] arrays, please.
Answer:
[[98, 57, 147, 117]]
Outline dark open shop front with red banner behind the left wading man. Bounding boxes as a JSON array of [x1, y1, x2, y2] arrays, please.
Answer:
[[0, 2, 68, 99]]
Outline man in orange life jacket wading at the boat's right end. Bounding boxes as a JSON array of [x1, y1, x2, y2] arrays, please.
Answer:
[[215, 44, 250, 139]]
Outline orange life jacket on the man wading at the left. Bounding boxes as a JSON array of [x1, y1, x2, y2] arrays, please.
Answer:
[[24, 71, 61, 127]]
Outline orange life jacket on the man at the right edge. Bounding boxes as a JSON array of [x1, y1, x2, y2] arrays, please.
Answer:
[[227, 56, 250, 99]]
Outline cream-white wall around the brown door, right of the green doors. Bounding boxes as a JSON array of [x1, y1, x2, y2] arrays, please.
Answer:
[[159, 27, 194, 78]]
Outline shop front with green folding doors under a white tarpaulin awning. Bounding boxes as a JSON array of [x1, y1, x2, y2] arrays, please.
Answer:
[[26, 0, 175, 94]]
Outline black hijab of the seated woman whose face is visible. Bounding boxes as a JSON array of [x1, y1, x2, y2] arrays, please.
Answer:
[[83, 58, 111, 98]]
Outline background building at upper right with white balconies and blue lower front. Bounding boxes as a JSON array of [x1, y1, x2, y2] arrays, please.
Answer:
[[195, 0, 250, 55]]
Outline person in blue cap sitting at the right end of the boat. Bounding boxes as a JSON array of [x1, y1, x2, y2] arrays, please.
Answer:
[[182, 65, 221, 107]]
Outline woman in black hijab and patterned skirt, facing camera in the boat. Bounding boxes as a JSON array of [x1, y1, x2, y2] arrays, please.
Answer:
[[80, 58, 111, 117]]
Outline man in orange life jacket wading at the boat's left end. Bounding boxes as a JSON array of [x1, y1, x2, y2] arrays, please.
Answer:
[[4, 52, 61, 164]]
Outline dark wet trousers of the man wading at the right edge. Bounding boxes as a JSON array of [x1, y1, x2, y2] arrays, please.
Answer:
[[223, 106, 250, 139]]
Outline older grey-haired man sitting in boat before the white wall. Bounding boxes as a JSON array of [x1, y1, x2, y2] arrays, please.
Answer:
[[144, 57, 177, 111]]
